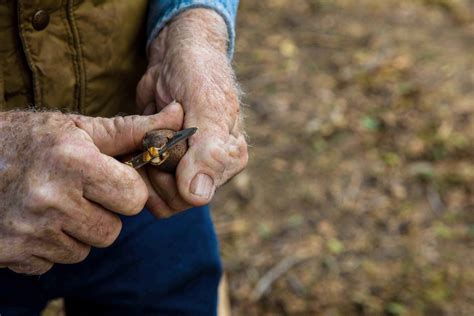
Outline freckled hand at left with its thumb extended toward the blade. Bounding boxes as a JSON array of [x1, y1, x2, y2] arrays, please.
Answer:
[[0, 105, 183, 274]]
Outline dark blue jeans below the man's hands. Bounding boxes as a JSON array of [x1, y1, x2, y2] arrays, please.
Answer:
[[0, 207, 222, 316]]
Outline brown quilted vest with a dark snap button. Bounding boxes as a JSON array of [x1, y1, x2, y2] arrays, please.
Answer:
[[0, 0, 147, 116]]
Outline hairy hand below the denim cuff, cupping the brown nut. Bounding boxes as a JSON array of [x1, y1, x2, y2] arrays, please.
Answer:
[[137, 9, 248, 216]]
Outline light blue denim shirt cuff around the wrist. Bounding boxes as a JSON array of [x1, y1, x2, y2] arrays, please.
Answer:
[[147, 0, 239, 58]]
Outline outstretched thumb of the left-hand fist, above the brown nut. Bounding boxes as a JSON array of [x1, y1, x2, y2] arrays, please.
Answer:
[[71, 102, 184, 156]]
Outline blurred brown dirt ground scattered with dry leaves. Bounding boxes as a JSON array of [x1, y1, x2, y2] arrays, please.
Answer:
[[214, 0, 474, 315]]
